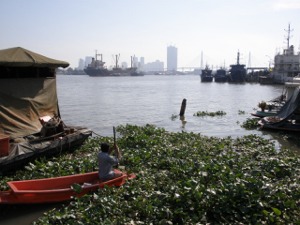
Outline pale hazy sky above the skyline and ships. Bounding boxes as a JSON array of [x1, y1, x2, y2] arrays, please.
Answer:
[[0, 0, 300, 67]]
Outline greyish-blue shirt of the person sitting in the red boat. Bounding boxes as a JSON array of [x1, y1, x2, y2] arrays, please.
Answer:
[[98, 152, 119, 180]]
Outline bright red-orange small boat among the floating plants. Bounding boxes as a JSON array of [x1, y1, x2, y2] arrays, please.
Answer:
[[0, 170, 136, 204]]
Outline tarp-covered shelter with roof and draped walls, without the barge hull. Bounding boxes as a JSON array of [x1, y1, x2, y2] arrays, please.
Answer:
[[0, 47, 69, 139]]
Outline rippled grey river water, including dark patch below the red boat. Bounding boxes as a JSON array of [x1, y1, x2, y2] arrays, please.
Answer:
[[0, 75, 299, 225]]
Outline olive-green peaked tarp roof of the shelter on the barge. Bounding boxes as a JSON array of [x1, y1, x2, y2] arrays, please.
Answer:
[[0, 47, 69, 68]]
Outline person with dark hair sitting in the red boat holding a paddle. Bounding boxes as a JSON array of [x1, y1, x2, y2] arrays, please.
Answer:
[[98, 143, 122, 181]]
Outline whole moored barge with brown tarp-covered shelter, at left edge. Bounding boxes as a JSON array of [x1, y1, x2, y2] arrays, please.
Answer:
[[0, 47, 92, 174]]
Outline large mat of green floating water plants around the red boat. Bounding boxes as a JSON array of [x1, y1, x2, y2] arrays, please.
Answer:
[[0, 125, 300, 225]]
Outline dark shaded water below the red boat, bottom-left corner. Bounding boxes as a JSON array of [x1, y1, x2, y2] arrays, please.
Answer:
[[0, 203, 62, 225]]
